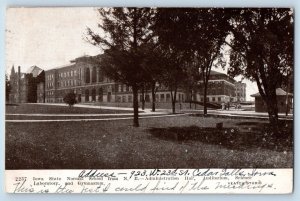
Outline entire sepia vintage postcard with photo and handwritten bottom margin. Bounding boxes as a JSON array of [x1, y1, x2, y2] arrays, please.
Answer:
[[5, 7, 295, 194]]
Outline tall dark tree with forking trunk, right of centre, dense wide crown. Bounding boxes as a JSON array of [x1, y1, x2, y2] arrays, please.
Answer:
[[157, 8, 228, 114]]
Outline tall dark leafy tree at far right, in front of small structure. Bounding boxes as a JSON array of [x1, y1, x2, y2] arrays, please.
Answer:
[[229, 8, 294, 132]]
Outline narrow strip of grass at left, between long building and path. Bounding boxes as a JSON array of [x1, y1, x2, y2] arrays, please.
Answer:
[[5, 104, 132, 114]]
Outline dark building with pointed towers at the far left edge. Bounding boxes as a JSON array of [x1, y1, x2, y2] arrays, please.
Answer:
[[9, 66, 45, 103]]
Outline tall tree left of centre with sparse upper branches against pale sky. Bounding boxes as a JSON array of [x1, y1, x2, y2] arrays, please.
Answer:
[[87, 8, 153, 127]]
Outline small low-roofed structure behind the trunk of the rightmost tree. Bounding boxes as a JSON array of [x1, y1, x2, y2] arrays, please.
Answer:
[[251, 88, 293, 113]]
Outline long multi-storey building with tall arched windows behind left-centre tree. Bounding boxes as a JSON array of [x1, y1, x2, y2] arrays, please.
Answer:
[[45, 56, 186, 103]]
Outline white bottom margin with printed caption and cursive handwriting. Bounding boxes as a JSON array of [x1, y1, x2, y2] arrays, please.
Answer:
[[5, 169, 293, 194]]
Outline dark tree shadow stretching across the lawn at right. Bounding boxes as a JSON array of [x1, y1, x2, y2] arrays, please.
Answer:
[[149, 122, 293, 151]]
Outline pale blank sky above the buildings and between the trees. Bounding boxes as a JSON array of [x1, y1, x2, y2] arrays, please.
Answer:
[[6, 7, 258, 100]]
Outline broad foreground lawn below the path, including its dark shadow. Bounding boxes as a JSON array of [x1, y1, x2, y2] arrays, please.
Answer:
[[5, 116, 293, 169]]
